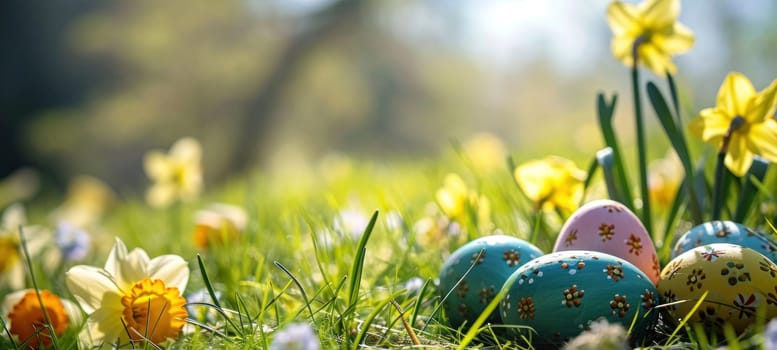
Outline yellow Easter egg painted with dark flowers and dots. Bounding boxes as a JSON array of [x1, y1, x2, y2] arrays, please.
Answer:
[[658, 243, 777, 332]]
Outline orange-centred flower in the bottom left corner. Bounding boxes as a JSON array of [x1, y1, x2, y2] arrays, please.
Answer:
[[2, 289, 81, 349]]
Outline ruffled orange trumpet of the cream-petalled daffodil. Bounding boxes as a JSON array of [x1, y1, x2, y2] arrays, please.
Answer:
[[121, 278, 187, 344]]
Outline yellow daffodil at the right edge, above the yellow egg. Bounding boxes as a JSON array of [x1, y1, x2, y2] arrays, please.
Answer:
[[688, 73, 777, 176]]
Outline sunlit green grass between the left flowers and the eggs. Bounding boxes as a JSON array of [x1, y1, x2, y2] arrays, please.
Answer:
[[0, 144, 776, 349]]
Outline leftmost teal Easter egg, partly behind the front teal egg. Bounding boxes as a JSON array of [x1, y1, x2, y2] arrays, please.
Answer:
[[439, 235, 542, 328]]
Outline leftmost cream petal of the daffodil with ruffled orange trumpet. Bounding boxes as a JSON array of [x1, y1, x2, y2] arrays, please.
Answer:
[[65, 265, 121, 314]]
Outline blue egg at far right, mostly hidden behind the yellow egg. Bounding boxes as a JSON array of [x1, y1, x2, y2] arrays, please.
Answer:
[[672, 220, 777, 263]]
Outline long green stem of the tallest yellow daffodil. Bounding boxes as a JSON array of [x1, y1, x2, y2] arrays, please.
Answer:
[[631, 65, 653, 232]]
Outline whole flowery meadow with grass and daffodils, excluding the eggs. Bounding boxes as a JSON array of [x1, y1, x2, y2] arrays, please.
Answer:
[[0, 0, 777, 349]]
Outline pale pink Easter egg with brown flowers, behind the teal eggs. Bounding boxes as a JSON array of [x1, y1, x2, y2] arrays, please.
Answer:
[[553, 199, 659, 284]]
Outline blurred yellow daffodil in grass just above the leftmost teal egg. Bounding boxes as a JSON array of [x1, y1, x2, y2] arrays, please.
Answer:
[[436, 174, 491, 224]]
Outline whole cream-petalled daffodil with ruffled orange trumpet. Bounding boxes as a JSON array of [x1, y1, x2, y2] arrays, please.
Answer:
[[65, 238, 189, 347]]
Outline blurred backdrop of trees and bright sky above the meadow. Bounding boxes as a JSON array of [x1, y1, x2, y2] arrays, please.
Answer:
[[0, 0, 777, 197]]
